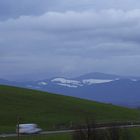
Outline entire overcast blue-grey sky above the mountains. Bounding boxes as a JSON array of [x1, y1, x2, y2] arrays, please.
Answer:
[[0, 0, 140, 81]]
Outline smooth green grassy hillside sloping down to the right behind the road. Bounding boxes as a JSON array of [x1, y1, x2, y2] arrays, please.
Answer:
[[0, 86, 140, 132]]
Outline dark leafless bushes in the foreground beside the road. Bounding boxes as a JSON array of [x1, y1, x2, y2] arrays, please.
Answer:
[[73, 122, 131, 140]]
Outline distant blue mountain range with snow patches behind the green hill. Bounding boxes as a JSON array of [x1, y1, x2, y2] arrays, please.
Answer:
[[0, 72, 140, 108]]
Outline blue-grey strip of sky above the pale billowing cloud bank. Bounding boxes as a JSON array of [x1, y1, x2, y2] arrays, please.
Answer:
[[0, 0, 140, 20]]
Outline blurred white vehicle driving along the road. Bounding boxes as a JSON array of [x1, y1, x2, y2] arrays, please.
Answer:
[[16, 124, 42, 134]]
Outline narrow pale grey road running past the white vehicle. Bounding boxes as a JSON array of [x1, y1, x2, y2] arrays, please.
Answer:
[[0, 125, 140, 138]]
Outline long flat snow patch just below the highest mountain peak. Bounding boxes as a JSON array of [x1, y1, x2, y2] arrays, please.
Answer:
[[82, 79, 113, 85]]
